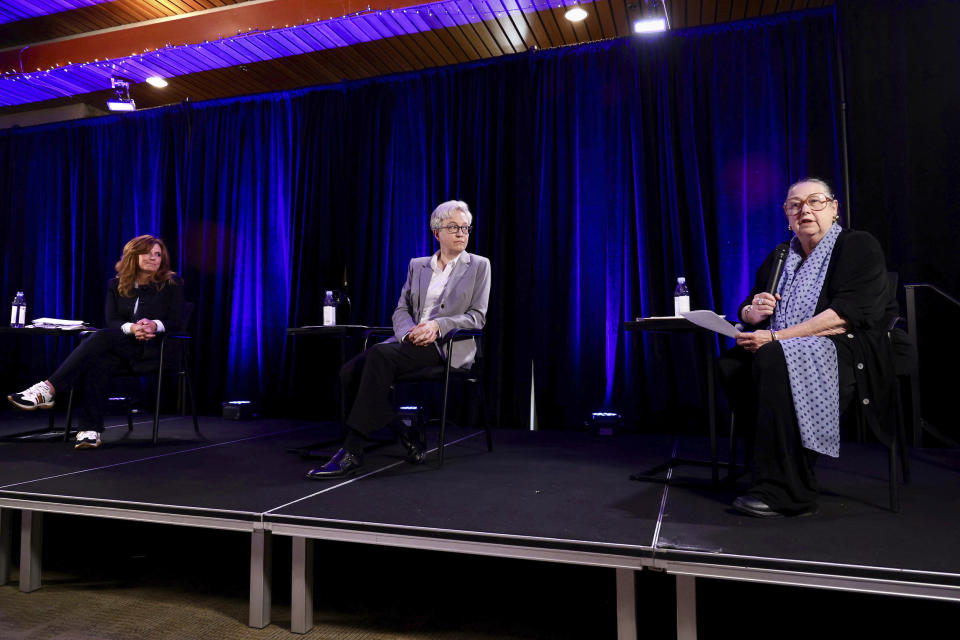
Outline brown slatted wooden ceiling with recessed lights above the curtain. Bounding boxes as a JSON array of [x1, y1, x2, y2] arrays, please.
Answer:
[[0, 0, 832, 119]]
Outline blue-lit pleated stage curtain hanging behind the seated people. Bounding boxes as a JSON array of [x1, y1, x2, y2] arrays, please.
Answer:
[[0, 10, 842, 429]]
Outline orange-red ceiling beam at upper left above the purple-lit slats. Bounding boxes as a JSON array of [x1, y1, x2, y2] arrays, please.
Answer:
[[0, 0, 423, 73]]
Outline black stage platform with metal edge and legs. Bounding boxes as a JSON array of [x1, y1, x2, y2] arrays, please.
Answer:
[[0, 413, 960, 638]]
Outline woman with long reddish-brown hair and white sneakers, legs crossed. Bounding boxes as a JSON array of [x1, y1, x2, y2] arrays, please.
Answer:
[[7, 235, 183, 449]]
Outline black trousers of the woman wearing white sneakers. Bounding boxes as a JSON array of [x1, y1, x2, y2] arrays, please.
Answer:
[[47, 329, 152, 431]]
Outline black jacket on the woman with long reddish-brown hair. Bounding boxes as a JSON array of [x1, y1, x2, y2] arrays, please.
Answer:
[[103, 278, 185, 333]]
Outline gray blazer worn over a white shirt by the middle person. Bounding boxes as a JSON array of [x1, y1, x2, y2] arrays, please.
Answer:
[[393, 251, 490, 368]]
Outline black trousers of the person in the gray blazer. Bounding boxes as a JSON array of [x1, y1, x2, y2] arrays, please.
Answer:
[[340, 342, 443, 453]]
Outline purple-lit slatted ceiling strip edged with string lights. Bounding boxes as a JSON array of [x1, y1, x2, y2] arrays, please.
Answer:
[[0, 0, 593, 106]]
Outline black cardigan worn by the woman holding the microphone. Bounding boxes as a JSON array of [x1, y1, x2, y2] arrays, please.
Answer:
[[737, 229, 899, 445]]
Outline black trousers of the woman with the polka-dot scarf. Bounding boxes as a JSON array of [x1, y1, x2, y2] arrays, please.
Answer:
[[718, 342, 856, 514]]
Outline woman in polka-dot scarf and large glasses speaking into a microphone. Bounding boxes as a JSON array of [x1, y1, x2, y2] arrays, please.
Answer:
[[719, 178, 897, 517]]
